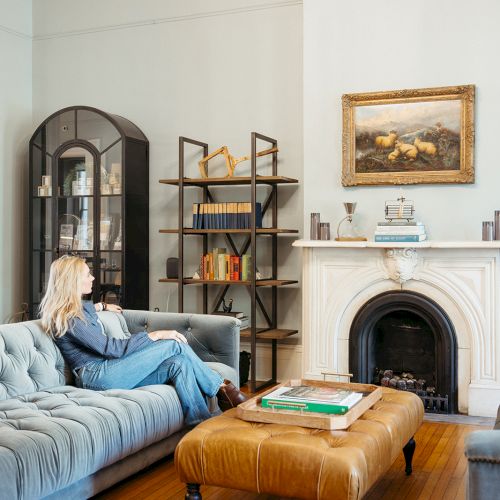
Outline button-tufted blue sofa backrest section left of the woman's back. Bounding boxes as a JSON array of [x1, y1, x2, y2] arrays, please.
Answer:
[[0, 321, 65, 402]]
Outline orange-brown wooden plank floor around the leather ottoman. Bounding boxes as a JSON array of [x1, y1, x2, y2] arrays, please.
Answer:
[[95, 421, 485, 500]]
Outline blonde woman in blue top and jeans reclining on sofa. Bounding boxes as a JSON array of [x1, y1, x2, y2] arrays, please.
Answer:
[[40, 255, 246, 426]]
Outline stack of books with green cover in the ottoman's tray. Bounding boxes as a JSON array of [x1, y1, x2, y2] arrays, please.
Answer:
[[261, 385, 363, 415]]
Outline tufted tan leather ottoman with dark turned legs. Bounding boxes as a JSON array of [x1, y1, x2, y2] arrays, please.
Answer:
[[175, 388, 424, 500]]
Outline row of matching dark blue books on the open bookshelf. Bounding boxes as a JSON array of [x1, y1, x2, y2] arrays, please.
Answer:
[[193, 201, 262, 229]]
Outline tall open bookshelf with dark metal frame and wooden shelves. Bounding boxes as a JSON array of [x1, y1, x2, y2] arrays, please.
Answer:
[[158, 132, 298, 392]]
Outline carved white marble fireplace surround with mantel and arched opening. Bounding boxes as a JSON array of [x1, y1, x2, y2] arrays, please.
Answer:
[[294, 240, 500, 416]]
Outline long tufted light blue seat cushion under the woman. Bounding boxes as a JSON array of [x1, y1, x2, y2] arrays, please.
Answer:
[[0, 385, 184, 500]]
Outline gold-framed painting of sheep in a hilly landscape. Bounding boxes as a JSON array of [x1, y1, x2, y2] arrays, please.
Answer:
[[342, 85, 475, 186]]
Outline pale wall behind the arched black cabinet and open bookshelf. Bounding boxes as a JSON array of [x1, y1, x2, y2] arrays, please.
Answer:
[[33, 0, 303, 376]]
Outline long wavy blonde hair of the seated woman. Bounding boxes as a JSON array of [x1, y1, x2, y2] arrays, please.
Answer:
[[40, 255, 85, 337]]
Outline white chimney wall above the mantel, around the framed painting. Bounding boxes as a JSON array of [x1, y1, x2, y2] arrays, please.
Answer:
[[304, 0, 500, 240]]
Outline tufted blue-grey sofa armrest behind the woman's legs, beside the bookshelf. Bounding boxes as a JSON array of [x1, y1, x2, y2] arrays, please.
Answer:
[[123, 309, 241, 375]]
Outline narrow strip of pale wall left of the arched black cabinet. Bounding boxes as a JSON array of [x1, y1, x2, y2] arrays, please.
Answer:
[[0, 0, 31, 322]]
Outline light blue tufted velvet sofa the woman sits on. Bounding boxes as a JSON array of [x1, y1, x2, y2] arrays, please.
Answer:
[[0, 311, 240, 500]]
